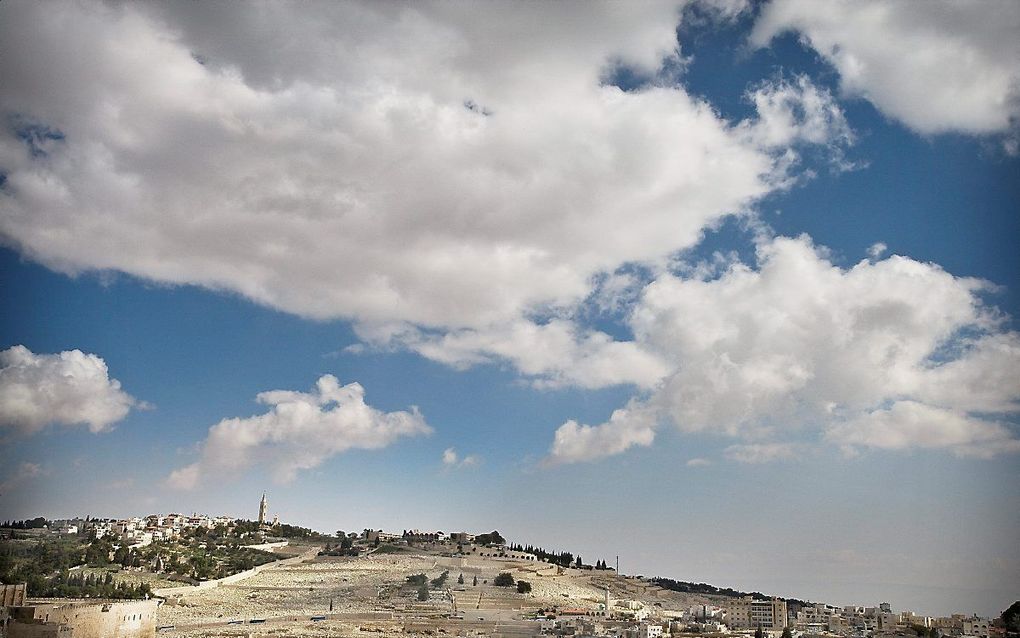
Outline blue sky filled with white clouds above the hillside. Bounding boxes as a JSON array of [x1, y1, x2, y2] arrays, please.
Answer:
[[0, 0, 1020, 616]]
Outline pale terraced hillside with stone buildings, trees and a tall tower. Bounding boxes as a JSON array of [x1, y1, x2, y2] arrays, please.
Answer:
[[0, 496, 1020, 638]]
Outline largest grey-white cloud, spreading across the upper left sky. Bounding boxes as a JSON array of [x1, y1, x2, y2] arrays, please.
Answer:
[[0, 2, 816, 336]]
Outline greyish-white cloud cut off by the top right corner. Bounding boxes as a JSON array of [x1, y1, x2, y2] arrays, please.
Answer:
[[751, 0, 1020, 134]]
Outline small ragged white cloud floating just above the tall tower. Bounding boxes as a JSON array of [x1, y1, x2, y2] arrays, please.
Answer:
[[167, 375, 432, 489]]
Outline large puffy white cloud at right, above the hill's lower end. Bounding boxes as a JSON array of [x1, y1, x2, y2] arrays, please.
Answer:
[[552, 237, 1020, 462]]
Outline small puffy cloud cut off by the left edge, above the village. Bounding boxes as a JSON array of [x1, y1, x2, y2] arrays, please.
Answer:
[[0, 346, 137, 434]]
